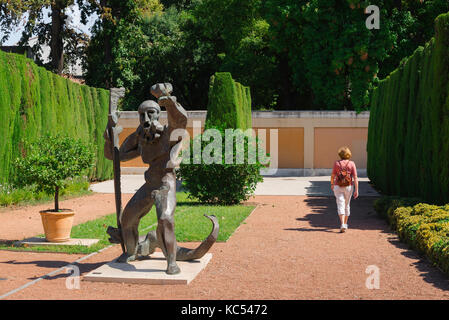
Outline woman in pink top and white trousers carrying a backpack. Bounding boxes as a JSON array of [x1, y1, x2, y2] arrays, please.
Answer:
[[331, 147, 359, 232]]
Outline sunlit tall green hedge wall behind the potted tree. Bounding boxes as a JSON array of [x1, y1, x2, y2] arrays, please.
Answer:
[[0, 51, 112, 183]]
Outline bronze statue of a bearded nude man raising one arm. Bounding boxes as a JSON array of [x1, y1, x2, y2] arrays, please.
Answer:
[[104, 83, 218, 274]]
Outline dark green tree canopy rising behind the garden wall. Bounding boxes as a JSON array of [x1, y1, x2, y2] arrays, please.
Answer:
[[0, 0, 449, 110]]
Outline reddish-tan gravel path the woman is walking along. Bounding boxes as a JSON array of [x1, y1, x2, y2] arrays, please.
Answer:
[[0, 195, 449, 300]]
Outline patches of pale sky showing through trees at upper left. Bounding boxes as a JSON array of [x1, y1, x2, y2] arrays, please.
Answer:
[[0, 4, 97, 46]]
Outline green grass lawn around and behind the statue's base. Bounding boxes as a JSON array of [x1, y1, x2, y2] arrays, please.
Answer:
[[0, 192, 254, 253]]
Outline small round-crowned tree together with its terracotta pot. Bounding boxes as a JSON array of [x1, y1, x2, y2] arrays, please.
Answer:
[[15, 135, 94, 242]]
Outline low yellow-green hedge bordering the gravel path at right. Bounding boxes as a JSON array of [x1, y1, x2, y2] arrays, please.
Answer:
[[374, 197, 449, 275]]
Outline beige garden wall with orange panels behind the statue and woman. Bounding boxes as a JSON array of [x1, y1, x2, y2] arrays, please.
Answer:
[[114, 111, 369, 175]]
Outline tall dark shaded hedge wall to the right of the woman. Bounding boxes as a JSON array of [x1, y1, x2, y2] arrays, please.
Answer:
[[367, 13, 449, 204]]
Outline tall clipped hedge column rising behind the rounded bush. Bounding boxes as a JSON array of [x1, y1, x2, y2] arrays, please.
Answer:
[[205, 72, 252, 130]]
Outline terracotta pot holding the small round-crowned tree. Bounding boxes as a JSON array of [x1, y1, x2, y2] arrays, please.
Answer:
[[40, 209, 75, 242]]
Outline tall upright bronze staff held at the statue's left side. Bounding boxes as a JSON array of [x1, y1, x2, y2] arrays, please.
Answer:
[[108, 88, 126, 252]]
